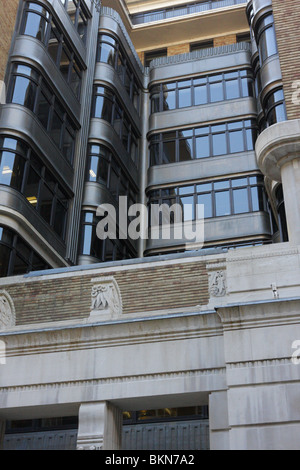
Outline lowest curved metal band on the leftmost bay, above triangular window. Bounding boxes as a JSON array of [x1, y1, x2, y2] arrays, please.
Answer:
[[0, 185, 66, 257]]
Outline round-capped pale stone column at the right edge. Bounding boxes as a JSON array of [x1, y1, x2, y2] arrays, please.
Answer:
[[256, 119, 300, 245]]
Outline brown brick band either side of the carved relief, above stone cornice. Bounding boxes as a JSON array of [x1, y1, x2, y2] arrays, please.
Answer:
[[4, 262, 209, 325]]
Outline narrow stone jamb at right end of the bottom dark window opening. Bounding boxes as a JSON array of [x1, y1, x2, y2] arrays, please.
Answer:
[[209, 391, 230, 450]]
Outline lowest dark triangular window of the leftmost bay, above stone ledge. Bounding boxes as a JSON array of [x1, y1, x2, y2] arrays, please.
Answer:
[[0, 225, 50, 277]]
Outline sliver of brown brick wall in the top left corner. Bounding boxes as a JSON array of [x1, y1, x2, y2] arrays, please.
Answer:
[[0, 0, 19, 80]]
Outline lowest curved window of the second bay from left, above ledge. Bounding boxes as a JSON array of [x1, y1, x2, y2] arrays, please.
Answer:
[[79, 211, 134, 263]]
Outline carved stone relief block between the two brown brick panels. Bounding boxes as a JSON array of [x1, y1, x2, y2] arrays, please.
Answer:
[[90, 276, 123, 319]]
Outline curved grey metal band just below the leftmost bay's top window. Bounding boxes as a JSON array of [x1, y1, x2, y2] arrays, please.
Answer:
[[10, 36, 80, 125]]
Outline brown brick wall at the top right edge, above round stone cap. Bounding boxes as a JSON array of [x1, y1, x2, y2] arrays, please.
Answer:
[[272, 0, 300, 123]]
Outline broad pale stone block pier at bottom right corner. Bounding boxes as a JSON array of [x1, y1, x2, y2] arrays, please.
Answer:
[[216, 302, 300, 451]]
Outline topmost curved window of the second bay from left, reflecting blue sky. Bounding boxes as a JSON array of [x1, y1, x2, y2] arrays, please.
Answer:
[[97, 34, 140, 113]]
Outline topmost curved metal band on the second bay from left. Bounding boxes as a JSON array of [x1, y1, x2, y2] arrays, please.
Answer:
[[99, 8, 144, 86]]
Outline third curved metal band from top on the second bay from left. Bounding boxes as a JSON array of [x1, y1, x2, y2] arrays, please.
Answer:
[[89, 118, 139, 188]]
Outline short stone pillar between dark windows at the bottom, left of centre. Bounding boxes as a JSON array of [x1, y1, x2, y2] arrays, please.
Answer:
[[77, 402, 122, 450]]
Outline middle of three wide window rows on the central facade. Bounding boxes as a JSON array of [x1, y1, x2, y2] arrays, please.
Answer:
[[150, 120, 257, 166]]
